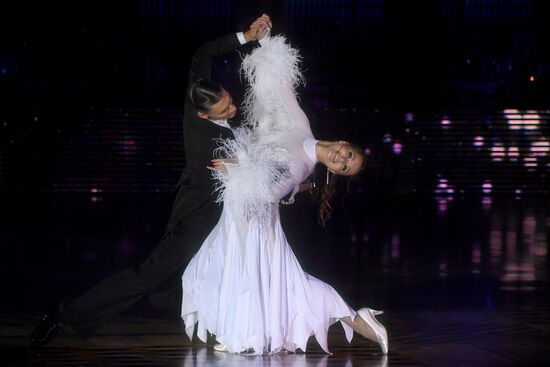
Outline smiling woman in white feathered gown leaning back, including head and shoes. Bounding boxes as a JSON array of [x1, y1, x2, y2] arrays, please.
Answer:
[[182, 37, 388, 354]]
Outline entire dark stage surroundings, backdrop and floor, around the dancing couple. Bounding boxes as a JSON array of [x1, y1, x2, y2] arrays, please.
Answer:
[[0, 0, 550, 367]]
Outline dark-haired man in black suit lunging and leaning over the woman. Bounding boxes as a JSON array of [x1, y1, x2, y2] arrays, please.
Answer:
[[29, 14, 271, 348]]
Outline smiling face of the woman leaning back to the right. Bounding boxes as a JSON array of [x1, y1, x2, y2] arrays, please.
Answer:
[[325, 141, 363, 176]]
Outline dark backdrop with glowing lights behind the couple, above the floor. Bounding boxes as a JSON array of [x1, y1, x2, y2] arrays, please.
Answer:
[[0, 0, 550, 195]]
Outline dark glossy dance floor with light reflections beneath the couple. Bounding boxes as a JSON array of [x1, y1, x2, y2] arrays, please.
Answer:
[[0, 195, 550, 366]]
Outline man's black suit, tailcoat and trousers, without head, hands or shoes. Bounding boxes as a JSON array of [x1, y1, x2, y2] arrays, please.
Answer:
[[60, 34, 252, 338]]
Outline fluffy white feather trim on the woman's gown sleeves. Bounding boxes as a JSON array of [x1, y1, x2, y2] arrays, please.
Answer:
[[213, 36, 302, 220]]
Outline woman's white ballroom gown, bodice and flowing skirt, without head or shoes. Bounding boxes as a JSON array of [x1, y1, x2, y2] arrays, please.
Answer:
[[182, 37, 356, 354]]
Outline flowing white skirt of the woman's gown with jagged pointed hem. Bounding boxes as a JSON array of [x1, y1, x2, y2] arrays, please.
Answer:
[[182, 207, 355, 354]]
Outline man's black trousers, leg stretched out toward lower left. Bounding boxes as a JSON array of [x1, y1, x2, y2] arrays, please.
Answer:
[[59, 188, 221, 339]]
